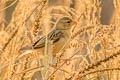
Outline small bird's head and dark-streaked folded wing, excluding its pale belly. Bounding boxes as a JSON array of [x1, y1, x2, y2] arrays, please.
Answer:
[[33, 17, 75, 49]]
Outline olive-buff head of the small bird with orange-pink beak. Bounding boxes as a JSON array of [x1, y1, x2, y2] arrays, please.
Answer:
[[56, 17, 77, 30]]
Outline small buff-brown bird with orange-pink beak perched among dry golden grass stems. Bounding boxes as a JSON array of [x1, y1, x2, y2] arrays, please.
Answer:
[[21, 16, 77, 57]]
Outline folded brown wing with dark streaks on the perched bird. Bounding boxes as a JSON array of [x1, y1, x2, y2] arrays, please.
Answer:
[[33, 30, 63, 49]]
